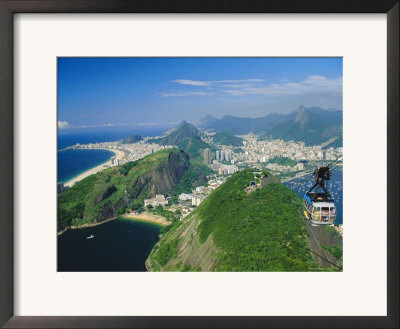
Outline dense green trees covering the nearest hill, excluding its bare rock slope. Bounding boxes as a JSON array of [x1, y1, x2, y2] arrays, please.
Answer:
[[196, 170, 315, 271]]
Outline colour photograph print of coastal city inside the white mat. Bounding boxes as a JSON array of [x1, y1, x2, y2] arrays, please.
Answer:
[[57, 57, 343, 272]]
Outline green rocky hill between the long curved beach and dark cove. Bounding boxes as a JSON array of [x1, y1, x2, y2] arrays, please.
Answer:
[[57, 148, 206, 231]]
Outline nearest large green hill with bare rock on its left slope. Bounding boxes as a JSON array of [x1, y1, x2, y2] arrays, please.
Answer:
[[147, 170, 316, 271]]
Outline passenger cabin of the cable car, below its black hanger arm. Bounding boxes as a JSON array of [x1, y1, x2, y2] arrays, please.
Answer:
[[304, 194, 336, 225]]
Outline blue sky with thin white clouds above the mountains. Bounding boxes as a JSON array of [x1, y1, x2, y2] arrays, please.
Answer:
[[58, 57, 342, 130]]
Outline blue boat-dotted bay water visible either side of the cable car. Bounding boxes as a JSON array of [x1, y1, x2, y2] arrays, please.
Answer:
[[284, 167, 343, 224]]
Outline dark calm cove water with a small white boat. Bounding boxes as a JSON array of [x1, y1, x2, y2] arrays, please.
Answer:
[[57, 219, 161, 272]]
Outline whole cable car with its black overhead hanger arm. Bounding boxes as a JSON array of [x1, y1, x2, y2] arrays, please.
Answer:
[[304, 166, 336, 225]]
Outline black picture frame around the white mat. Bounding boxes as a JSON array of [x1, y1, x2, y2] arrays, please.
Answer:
[[0, 0, 400, 328]]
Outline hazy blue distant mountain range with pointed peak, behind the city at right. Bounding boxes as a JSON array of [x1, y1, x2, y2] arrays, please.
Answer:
[[200, 105, 343, 147]]
